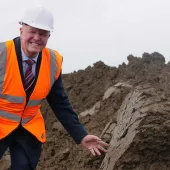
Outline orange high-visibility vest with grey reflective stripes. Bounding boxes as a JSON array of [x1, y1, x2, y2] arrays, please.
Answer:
[[0, 40, 62, 143]]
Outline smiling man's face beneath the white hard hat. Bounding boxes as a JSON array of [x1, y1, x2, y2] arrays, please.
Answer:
[[20, 25, 50, 57]]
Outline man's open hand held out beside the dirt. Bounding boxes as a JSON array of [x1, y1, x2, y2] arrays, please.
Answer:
[[81, 135, 109, 156]]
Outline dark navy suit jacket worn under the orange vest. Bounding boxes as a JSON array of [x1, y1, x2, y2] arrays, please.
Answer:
[[14, 37, 87, 144]]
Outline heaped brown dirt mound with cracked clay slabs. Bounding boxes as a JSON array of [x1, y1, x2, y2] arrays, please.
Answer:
[[0, 52, 170, 170]]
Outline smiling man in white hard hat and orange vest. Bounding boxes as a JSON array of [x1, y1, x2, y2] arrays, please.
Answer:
[[0, 7, 108, 170]]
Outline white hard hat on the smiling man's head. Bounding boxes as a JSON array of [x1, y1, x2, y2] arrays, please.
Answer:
[[19, 7, 54, 31]]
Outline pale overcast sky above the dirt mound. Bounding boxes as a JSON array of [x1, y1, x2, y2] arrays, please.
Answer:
[[0, 0, 170, 73]]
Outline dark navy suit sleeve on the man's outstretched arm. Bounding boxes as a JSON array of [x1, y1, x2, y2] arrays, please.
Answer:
[[47, 71, 87, 144]]
